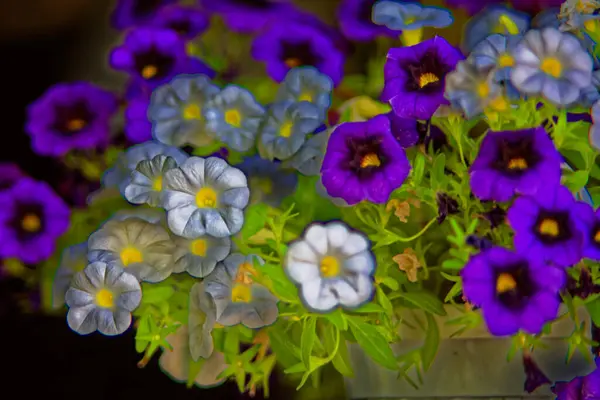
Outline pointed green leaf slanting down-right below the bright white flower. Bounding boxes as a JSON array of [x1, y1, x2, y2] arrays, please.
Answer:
[[348, 316, 398, 370]]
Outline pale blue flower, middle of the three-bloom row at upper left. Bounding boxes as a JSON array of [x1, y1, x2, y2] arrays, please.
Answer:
[[204, 85, 265, 151]]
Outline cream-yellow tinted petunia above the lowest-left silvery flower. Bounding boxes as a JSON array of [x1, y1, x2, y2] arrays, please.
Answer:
[[88, 217, 175, 283]]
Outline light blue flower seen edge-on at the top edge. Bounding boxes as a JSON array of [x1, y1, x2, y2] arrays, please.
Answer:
[[372, 0, 454, 31]]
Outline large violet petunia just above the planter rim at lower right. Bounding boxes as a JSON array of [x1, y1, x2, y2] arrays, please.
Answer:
[[461, 247, 566, 336]]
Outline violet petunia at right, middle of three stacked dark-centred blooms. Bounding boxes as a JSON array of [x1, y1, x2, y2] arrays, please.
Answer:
[[507, 185, 584, 267]]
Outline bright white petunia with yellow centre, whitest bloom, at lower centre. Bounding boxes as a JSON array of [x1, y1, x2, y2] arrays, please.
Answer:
[[284, 222, 376, 313]]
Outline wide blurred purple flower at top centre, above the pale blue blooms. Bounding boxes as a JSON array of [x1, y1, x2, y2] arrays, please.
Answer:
[[252, 20, 344, 85]]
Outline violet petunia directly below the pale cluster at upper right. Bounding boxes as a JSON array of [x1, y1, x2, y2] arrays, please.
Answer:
[[471, 127, 562, 202]]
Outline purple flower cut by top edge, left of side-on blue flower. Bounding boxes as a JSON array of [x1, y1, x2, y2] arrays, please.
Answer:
[[337, 0, 398, 41]]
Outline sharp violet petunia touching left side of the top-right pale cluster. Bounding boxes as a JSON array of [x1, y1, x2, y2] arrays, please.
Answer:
[[381, 36, 464, 120]]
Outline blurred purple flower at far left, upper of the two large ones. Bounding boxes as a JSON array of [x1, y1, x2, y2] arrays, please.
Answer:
[[25, 82, 117, 156]]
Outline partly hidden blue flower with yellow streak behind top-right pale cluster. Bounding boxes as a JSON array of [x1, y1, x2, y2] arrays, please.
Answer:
[[462, 5, 530, 53]]
